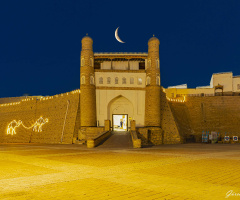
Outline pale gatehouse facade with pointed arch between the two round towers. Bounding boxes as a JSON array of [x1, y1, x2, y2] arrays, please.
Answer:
[[95, 71, 146, 127]]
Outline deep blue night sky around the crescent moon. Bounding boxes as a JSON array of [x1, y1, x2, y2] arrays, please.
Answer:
[[0, 0, 240, 97]]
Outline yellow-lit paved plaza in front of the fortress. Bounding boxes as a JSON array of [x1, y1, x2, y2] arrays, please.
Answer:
[[0, 144, 240, 200]]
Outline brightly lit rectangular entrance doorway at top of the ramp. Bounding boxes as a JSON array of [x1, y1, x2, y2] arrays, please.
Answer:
[[112, 114, 128, 131]]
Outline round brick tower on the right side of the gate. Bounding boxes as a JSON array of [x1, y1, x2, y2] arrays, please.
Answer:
[[145, 37, 161, 127]]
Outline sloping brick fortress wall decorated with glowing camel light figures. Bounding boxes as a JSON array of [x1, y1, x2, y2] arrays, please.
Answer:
[[0, 92, 80, 143]]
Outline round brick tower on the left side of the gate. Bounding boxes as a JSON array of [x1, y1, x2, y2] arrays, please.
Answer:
[[80, 36, 97, 127]]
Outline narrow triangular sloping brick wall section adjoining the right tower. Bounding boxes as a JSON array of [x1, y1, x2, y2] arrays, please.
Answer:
[[161, 92, 183, 144]]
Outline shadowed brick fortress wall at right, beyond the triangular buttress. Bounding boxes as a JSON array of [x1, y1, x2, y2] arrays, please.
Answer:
[[170, 96, 240, 142]]
